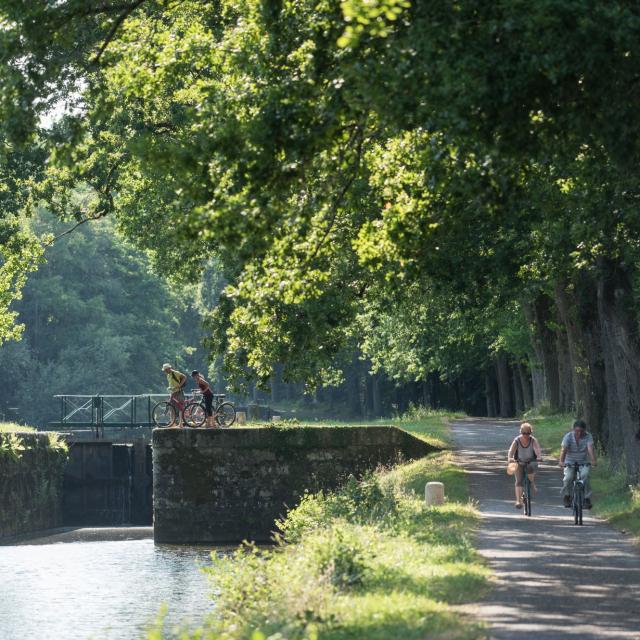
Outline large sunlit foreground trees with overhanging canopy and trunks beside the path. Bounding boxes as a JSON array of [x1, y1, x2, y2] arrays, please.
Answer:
[[0, 0, 640, 477]]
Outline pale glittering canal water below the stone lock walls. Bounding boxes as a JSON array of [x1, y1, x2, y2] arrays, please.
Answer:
[[0, 537, 218, 640]]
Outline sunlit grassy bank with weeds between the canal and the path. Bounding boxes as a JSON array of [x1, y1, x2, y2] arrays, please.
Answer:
[[165, 414, 488, 640]]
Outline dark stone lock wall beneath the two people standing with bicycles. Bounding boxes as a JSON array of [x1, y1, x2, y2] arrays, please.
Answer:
[[153, 426, 435, 543]]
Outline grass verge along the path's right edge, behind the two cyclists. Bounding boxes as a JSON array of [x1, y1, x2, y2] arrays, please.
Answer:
[[528, 415, 640, 538]]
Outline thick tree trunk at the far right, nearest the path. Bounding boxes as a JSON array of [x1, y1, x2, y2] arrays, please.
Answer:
[[597, 259, 640, 482]]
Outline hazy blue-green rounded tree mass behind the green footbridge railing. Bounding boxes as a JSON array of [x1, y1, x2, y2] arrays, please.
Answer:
[[0, 212, 204, 425]]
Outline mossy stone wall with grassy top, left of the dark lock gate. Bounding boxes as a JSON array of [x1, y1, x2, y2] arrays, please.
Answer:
[[0, 432, 67, 539]]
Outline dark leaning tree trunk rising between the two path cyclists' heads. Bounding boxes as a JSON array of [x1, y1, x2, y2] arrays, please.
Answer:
[[523, 292, 560, 411]]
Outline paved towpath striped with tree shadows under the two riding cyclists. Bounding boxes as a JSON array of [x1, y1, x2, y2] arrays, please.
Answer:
[[453, 419, 640, 640]]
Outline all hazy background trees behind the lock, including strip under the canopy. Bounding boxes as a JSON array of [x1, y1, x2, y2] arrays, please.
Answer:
[[0, 211, 460, 426]]
